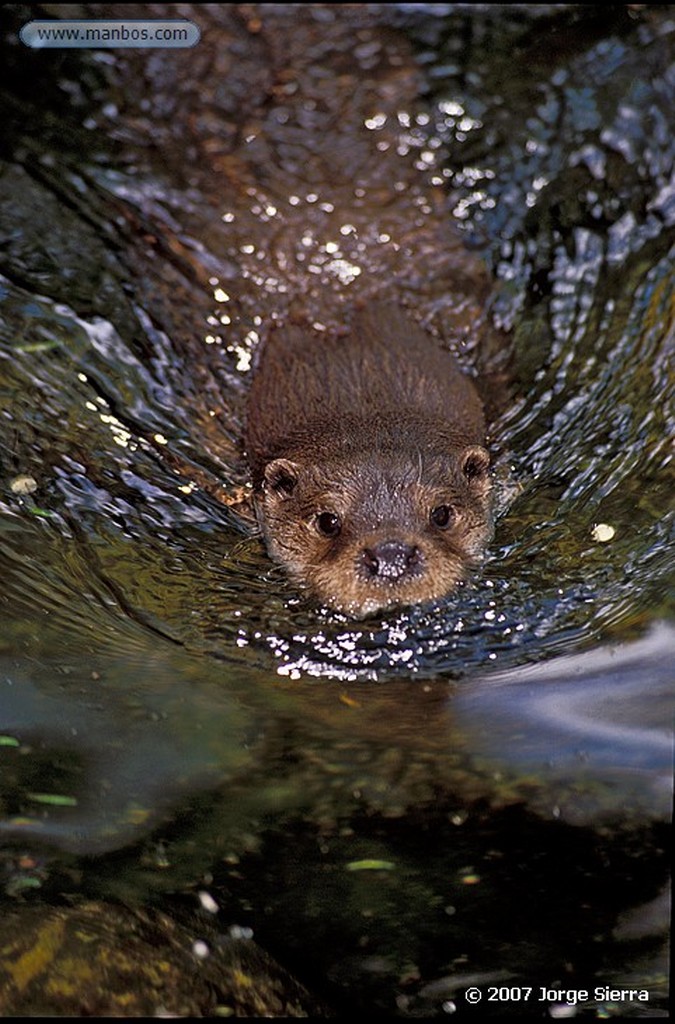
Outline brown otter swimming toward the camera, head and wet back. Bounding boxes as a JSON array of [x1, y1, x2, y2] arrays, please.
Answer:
[[245, 303, 492, 616]]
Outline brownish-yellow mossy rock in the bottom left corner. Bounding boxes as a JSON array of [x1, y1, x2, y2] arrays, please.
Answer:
[[0, 901, 330, 1017]]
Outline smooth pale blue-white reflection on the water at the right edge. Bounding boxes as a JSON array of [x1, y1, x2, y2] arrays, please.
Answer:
[[454, 624, 675, 824]]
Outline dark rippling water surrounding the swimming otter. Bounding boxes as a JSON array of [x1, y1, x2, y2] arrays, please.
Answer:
[[0, 4, 675, 1016]]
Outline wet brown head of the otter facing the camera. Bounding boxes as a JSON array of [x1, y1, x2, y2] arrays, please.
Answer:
[[256, 444, 492, 616]]
